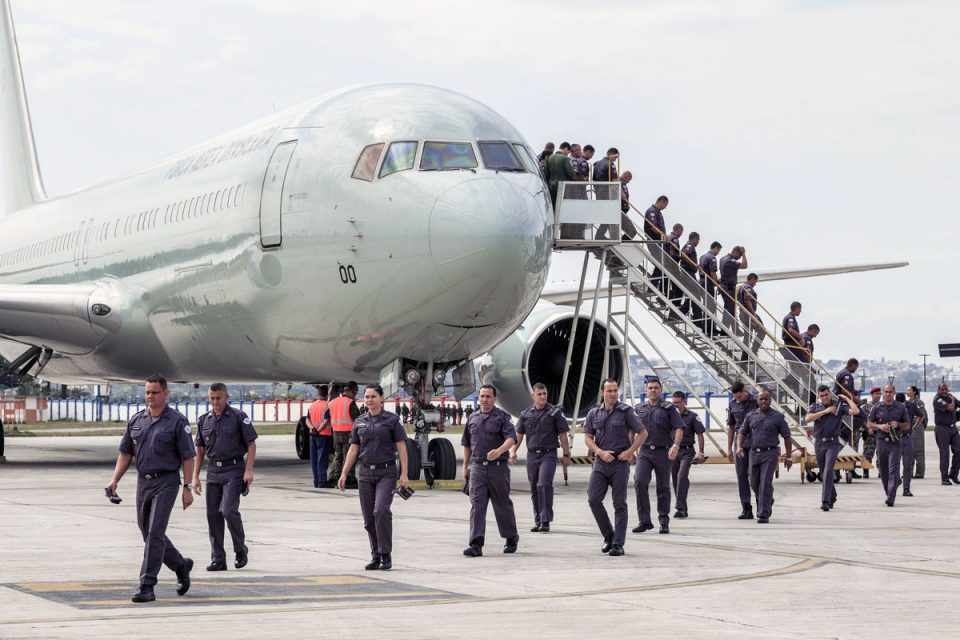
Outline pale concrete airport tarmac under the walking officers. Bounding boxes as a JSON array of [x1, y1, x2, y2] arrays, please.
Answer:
[[0, 432, 960, 640]]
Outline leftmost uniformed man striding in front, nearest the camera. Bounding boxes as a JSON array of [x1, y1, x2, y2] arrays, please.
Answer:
[[107, 376, 196, 602]]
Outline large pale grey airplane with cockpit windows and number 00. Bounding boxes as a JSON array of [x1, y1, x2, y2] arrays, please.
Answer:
[[0, 0, 904, 476]]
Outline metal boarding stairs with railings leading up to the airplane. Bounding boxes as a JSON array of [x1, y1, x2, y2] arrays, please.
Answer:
[[555, 183, 869, 481]]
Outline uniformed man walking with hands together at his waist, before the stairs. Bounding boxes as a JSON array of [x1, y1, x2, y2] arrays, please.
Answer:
[[583, 378, 647, 556]]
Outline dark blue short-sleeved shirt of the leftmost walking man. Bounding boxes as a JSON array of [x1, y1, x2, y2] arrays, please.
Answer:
[[120, 407, 197, 474]]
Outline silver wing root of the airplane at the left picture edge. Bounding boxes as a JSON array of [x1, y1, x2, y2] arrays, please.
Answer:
[[0, 282, 125, 355]]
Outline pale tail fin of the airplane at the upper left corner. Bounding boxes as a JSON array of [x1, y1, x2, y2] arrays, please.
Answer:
[[0, 0, 46, 216]]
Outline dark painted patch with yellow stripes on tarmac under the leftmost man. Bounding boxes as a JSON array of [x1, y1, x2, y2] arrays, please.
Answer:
[[2, 575, 469, 609]]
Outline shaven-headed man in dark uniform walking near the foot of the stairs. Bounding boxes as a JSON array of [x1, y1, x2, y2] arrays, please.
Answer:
[[737, 389, 793, 524]]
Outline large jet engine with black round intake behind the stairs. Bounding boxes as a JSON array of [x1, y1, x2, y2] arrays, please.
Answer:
[[478, 302, 623, 418]]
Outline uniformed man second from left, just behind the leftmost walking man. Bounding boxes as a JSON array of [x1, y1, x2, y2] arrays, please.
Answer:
[[193, 382, 257, 571]]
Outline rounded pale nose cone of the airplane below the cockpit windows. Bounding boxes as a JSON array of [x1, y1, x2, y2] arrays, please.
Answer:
[[430, 175, 552, 327]]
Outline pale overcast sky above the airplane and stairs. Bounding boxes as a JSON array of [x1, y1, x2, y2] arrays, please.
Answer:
[[13, 0, 960, 365]]
